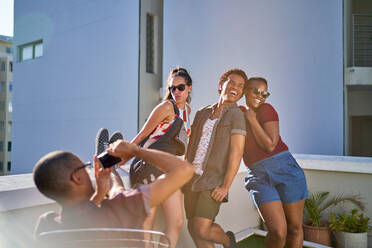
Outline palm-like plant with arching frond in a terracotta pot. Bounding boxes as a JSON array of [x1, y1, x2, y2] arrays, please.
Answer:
[[304, 192, 364, 246]]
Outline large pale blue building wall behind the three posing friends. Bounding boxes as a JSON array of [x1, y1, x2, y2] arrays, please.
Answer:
[[163, 0, 343, 155]]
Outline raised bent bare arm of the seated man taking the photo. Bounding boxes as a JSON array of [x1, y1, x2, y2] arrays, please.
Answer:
[[108, 140, 194, 207]]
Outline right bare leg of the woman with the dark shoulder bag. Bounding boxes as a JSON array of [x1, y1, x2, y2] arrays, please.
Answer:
[[162, 190, 183, 248]]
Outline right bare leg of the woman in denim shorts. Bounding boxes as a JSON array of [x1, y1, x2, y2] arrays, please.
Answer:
[[283, 200, 305, 248]]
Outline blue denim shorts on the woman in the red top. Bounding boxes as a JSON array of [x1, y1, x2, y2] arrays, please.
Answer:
[[245, 151, 308, 206]]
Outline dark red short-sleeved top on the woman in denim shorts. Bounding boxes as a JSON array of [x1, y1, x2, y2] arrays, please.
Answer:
[[243, 103, 288, 166]]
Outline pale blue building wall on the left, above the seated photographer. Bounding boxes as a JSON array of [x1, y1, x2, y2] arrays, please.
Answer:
[[12, 0, 139, 174]]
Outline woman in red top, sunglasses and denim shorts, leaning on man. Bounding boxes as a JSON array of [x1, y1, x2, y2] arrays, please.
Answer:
[[242, 78, 308, 247]]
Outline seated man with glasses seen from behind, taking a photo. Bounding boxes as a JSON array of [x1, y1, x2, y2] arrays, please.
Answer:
[[34, 140, 194, 237]]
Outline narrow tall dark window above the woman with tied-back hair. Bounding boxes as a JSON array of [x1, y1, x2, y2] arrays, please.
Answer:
[[146, 13, 155, 73]]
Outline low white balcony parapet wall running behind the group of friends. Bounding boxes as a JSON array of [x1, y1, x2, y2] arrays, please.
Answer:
[[0, 155, 372, 248]]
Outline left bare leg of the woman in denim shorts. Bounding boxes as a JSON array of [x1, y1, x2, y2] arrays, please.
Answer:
[[258, 201, 287, 248]]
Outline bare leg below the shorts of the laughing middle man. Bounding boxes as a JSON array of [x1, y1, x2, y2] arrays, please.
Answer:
[[192, 217, 230, 248]]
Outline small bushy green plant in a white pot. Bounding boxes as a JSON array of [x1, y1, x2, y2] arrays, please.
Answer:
[[329, 208, 370, 248]]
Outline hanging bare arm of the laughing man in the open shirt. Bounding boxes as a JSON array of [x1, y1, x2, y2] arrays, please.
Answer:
[[212, 134, 245, 201]]
